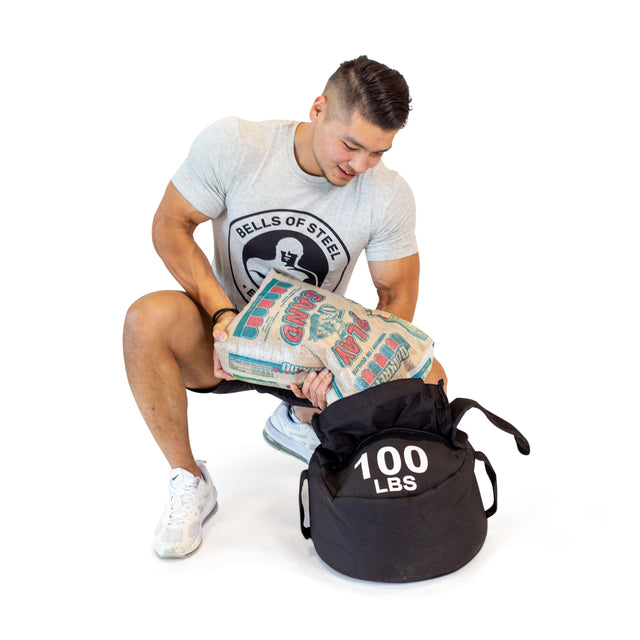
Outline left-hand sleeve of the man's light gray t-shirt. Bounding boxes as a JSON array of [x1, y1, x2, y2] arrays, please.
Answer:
[[172, 118, 235, 218]]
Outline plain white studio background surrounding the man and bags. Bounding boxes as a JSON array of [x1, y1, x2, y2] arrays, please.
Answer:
[[0, 0, 640, 638]]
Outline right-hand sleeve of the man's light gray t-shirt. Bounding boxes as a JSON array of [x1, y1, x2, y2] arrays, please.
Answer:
[[366, 175, 418, 261]]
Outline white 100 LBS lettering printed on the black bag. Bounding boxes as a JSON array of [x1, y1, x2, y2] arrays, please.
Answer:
[[353, 445, 429, 493]]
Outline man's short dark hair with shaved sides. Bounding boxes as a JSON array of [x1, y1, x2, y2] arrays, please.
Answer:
[[325, 56, 411, 131]]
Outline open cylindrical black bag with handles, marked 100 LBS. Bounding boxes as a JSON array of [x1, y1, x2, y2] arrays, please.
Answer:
[[300, 380, 529, 582]]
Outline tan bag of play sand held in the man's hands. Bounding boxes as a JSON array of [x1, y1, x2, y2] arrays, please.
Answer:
[[215, 270, 433, 403]]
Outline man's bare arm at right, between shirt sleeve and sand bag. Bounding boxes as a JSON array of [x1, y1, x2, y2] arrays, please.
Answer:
[[369, 253, 420, 322]]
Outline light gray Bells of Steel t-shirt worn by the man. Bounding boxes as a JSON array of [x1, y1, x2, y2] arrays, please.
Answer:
[[172, 118, 418, 308]]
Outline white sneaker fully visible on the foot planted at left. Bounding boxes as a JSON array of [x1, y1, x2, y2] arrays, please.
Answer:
[[153, 460, 218, 558]]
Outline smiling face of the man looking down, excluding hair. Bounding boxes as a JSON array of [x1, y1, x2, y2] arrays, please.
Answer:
[[312, 99, 397, 187]]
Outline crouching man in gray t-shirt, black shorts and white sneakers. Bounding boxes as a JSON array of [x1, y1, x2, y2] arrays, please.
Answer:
[[124, 56, 438, 556]]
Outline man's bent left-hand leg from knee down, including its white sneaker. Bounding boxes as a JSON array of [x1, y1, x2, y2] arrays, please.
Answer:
[[123, 291, 219, 557]]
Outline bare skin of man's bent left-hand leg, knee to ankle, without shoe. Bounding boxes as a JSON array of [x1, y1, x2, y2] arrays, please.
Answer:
[[123, 291, 219, 475]]
